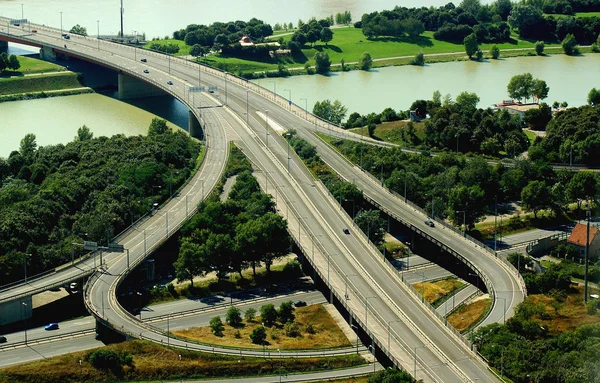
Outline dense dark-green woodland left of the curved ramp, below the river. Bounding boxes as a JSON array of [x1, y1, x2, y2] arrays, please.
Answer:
[[0, 119, 200, 284]]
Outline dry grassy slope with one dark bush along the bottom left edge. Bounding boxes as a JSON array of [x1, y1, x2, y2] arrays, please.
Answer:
[[0, 340, 365, 383]]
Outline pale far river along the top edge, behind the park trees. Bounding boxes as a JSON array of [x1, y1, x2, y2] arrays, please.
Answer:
[[0, 0, 492, 39]]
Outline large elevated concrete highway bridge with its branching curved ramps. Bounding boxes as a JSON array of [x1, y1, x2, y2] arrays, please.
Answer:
[[0, 19, 525, 382]]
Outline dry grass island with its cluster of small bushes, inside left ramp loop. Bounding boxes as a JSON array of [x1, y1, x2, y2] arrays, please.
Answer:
[[173, 301, 352, 352]]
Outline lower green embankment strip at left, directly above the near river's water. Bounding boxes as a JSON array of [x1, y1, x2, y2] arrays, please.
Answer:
[[0, 72, 82, 95]]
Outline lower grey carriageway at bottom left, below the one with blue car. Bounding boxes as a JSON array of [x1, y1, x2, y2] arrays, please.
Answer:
[[0, 334, 104, 367]]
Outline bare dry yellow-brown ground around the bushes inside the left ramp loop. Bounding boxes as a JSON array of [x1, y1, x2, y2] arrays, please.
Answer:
[[173, 305, 351, 350]]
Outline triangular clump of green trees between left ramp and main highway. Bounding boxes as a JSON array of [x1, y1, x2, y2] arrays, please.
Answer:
[[174, 150, 291, 284]]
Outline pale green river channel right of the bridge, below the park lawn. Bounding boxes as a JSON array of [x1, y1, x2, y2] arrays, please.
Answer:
[[262, 53, 600, 114]]
